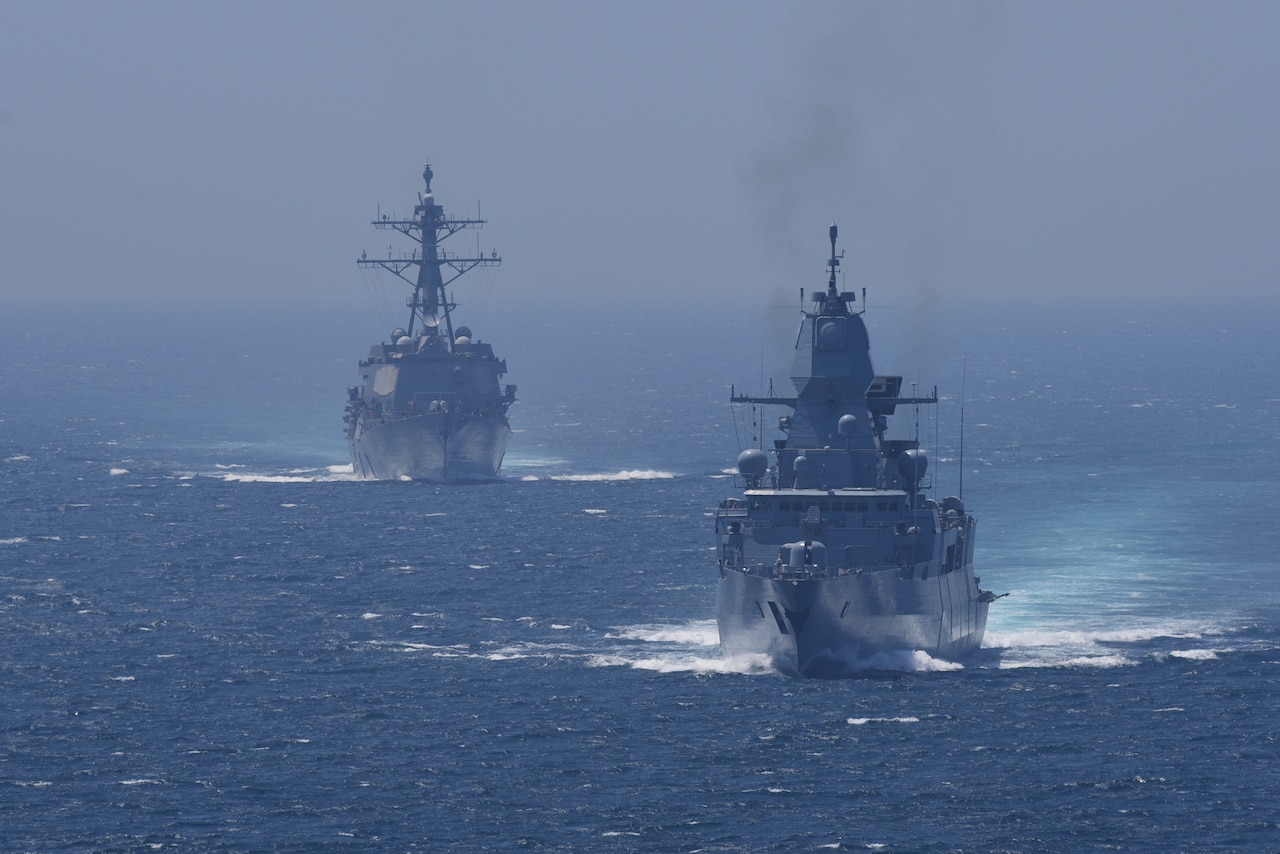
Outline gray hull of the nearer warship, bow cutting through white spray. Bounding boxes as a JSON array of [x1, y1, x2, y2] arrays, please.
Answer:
[[717, 566, 989, 676]]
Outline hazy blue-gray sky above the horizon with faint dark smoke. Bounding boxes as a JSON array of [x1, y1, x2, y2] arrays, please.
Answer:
[[0, 0, 1280, 302]]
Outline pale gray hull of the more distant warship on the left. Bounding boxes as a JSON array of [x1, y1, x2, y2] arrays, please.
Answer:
[[349, 412, 511, 483]]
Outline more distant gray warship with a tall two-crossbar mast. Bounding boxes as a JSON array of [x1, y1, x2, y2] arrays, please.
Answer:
[[343, 164, 516, 481]]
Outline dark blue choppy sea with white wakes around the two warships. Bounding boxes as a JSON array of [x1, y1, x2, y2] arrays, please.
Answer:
[[0, 294, 1280, 851]]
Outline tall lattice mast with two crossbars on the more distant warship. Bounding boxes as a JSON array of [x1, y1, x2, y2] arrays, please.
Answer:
[[356, 164, 502, 351]]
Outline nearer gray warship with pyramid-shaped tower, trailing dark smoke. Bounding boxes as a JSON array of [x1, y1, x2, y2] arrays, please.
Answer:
[[716, 225, 997, 676]]
